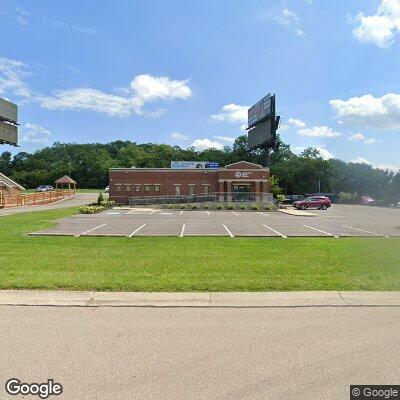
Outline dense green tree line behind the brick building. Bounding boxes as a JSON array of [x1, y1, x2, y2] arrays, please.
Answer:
[[0, 135, 400, 203]]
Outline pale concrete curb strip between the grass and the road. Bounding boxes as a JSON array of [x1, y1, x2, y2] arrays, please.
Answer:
[[0, 290, 400, 307]]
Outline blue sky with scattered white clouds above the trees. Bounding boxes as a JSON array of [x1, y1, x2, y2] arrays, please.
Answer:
[[0, 0, 400, 170]]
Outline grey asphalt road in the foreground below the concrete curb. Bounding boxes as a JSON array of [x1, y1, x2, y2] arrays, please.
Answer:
[[0, 306, 400, 400]]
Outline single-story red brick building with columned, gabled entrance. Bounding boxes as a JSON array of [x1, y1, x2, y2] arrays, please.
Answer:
[[109, 161, 270, 204]]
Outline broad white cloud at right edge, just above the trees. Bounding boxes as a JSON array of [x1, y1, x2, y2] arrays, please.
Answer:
[[329, 93, 400, 129]]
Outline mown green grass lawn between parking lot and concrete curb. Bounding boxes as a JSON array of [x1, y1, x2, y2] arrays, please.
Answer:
[[0, 208, 400, 291]]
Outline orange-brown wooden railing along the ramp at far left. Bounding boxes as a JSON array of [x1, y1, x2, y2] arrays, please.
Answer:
[[0, 189, 75, 208]]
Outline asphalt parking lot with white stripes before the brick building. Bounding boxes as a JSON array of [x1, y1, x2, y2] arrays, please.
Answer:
[[30, 205, 400, 239]]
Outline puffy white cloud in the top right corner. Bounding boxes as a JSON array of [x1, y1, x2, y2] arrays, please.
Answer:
[[353, 0, 400, 48]]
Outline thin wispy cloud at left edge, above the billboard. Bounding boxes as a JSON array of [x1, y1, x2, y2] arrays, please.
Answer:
[[0, 57, 32, 98]]
